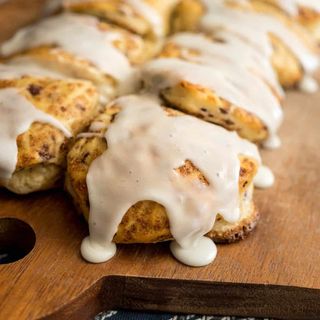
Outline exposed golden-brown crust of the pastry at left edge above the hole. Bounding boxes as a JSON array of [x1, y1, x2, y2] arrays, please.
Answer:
[[0, 77, 99, 193]]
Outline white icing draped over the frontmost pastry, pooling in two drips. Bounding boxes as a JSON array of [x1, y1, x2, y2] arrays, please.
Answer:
[[81, 96, 260, 265]]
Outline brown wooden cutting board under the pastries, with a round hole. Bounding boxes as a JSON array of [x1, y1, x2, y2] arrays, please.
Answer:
[[0, 1, 320, 319]]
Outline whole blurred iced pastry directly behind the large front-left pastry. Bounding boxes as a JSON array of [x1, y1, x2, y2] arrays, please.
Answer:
[[0, 13, 154, 101]]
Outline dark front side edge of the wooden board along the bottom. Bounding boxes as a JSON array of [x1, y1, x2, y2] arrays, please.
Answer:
[[41, 276, 320, 320]]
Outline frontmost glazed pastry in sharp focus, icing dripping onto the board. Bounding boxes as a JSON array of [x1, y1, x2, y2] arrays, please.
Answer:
[[66, 96, 260, 262]]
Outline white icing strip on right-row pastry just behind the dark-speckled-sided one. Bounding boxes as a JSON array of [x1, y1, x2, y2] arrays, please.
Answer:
[[169, 30, 284, 97]]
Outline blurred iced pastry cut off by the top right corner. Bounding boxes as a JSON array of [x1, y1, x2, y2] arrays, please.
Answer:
[[260, 0, 320, 43]]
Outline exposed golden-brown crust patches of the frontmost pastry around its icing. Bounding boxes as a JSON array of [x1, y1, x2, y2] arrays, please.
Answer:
[[65, 106, 257, 243]]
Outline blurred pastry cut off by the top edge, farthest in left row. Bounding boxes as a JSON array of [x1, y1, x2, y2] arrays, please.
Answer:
[[64, 0, 178, 39]]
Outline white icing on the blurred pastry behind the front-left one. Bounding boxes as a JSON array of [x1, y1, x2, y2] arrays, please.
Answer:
[[0, 13, 133, 82]]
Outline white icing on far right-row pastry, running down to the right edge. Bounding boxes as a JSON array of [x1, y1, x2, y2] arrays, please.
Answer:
[[201, 0, 319, 73]]
